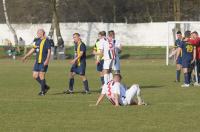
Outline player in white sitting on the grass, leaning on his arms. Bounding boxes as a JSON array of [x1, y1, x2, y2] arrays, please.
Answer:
[[96, 74, 145, 106]]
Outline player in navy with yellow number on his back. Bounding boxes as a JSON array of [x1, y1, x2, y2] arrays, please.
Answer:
[[176, 31, 196, 87]]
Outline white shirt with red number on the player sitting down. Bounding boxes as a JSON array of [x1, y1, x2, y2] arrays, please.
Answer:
[[101, 81, 126, 104]]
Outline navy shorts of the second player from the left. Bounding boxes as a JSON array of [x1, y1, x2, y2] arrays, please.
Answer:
[[70, 63, 86, 75]]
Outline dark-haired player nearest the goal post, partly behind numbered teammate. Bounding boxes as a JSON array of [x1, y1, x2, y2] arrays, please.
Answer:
[[174, 31, 182, 82]]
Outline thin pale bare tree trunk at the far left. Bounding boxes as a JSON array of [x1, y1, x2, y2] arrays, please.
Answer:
[[2, 0, 18, 46]]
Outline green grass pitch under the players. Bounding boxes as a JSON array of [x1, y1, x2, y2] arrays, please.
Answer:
[[0, 59, 200, 132]]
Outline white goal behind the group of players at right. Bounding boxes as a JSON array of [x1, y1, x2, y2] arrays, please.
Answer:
[[166, 21, 200, 66]]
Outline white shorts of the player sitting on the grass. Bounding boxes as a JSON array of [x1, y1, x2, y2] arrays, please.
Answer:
[[123, 84, 140, 105]]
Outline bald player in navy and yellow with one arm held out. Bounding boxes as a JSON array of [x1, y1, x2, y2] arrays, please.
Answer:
[[22, 29, 51, 96]]
